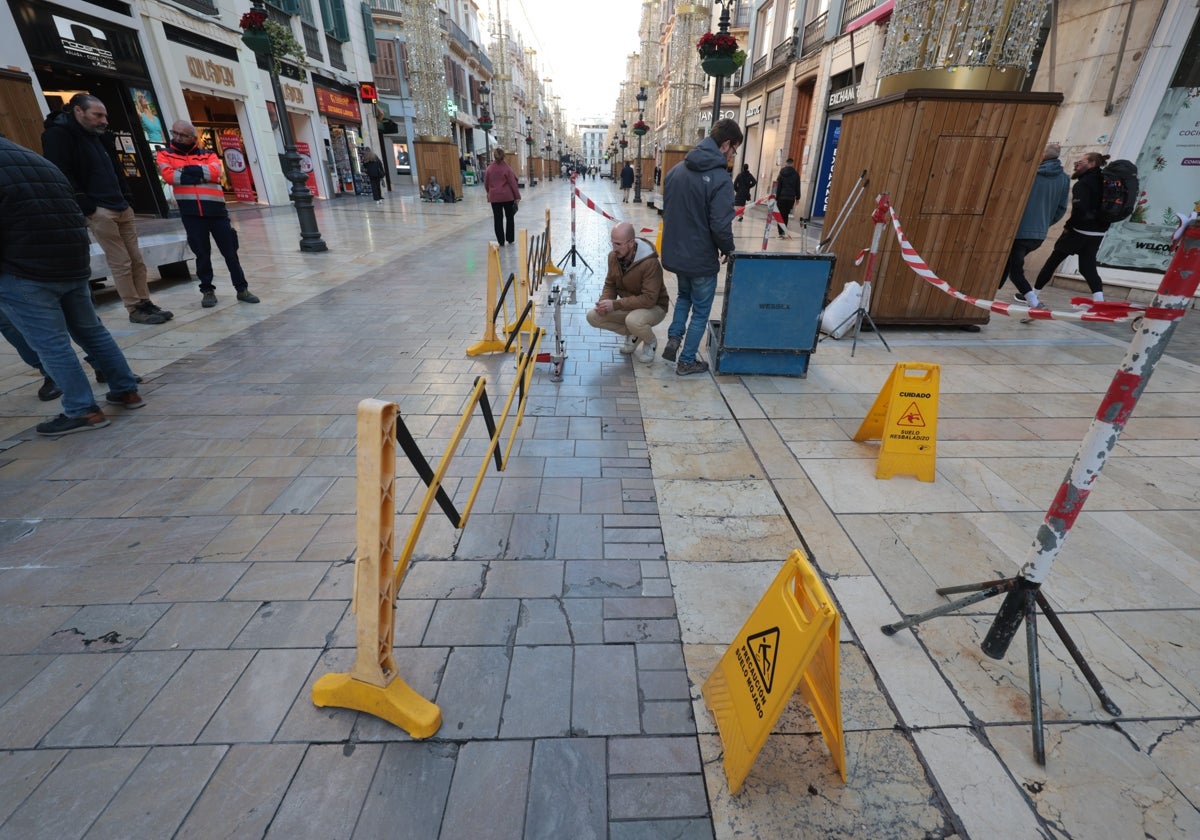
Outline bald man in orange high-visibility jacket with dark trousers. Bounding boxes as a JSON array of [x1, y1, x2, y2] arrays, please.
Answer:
[[157, 120, 258, 308]]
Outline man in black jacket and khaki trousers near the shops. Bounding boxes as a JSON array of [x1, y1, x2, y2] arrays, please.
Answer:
[[42, 94, 174, 324]]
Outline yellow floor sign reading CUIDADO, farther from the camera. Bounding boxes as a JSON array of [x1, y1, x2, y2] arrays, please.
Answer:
[[854, 361, 941, 481]]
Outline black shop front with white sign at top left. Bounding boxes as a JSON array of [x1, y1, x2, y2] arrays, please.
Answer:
[[10, 0, 168, 216]]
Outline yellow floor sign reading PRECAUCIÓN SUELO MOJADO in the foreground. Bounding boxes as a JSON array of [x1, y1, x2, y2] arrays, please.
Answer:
[[701, 550, 846, 793]]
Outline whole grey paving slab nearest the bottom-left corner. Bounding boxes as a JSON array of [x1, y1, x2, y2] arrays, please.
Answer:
[[0, 749, 146, 840]]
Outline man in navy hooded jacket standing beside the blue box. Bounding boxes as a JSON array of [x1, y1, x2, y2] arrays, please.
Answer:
[[662, 119, 742, 376]]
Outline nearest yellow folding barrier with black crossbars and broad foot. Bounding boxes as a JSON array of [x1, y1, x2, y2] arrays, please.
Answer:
[[312, 321, 545, 738]]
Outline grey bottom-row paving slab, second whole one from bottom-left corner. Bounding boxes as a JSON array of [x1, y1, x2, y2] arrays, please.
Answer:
[[88, 745, 228, 840]]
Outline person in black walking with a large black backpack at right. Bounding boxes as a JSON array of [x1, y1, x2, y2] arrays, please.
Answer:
[[1033, 151, 1138, 302]]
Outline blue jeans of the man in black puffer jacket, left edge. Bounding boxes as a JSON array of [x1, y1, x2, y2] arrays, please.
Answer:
[[0, 274, 138, 418]]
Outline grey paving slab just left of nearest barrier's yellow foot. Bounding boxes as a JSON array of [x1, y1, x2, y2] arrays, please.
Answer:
[[197, 650, 318, 743]]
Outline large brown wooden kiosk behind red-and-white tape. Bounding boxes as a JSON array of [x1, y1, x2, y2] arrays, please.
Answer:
[[829, 89, 1062, 325]]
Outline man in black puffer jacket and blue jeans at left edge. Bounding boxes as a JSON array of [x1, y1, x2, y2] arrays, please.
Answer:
[[0, 138, 145, 436]]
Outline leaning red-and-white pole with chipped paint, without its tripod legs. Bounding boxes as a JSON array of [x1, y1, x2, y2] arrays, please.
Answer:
[[983, 220, 1200, 659]]
